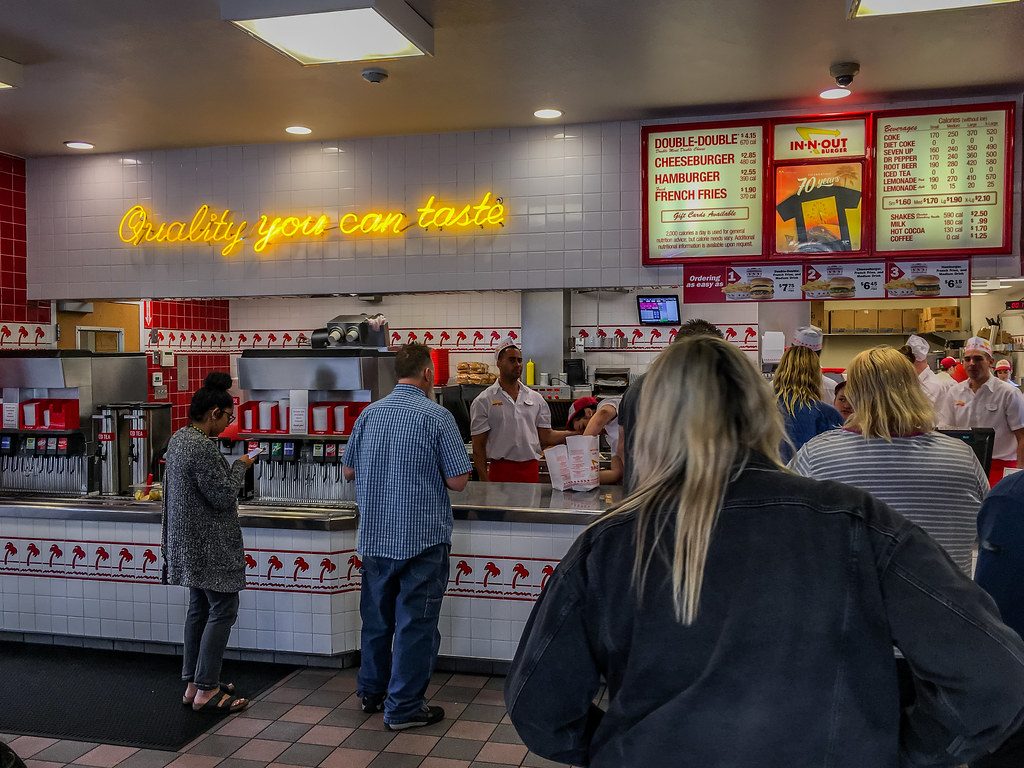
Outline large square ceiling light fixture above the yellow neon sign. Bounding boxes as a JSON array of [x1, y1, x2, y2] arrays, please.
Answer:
[[220, 0, 434, 67]]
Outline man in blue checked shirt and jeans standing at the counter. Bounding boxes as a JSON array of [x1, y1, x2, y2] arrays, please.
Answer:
[[342, 344, 472, 730]]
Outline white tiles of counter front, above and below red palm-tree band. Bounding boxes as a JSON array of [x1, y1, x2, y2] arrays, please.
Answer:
[[0, 517, 584, 659]]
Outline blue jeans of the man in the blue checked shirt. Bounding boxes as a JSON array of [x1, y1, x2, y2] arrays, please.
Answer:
[[357, 544, 451, 723]]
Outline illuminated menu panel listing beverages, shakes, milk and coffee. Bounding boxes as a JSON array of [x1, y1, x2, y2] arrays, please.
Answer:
[[874, 109, 1013, 253]]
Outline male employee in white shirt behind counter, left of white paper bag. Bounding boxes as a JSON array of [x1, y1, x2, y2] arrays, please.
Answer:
[[469, 339, 571, 482]]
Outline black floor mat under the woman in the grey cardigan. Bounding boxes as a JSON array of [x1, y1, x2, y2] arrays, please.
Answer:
[[0, 642, 296, 751]]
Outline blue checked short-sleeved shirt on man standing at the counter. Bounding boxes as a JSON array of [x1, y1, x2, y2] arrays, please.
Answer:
[[342, 384, 473, 560]]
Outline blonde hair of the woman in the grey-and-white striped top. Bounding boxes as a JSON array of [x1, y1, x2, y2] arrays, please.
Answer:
[[846, 346, 935, 441]]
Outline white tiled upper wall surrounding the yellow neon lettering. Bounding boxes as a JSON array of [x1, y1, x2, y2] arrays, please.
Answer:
[[28, 122, 700, 298]]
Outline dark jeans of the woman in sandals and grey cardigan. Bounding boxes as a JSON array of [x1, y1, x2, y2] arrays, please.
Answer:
[[181, 587, 239, 690]]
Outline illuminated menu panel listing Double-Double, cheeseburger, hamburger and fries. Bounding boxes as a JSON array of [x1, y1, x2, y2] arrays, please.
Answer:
[[643, 123, 765, 264]]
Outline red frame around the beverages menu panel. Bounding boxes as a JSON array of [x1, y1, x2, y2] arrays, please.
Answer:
[[871, 101, 1024, 259]]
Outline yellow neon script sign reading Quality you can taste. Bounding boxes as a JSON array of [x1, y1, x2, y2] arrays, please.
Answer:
[[118, 193, 505, 256]]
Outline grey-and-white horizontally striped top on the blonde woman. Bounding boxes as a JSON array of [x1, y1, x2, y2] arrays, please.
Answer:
[[790, 429, 988, 573]]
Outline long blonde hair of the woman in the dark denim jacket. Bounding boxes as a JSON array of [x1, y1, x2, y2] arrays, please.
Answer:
[[611, 336, 784, 624]]
